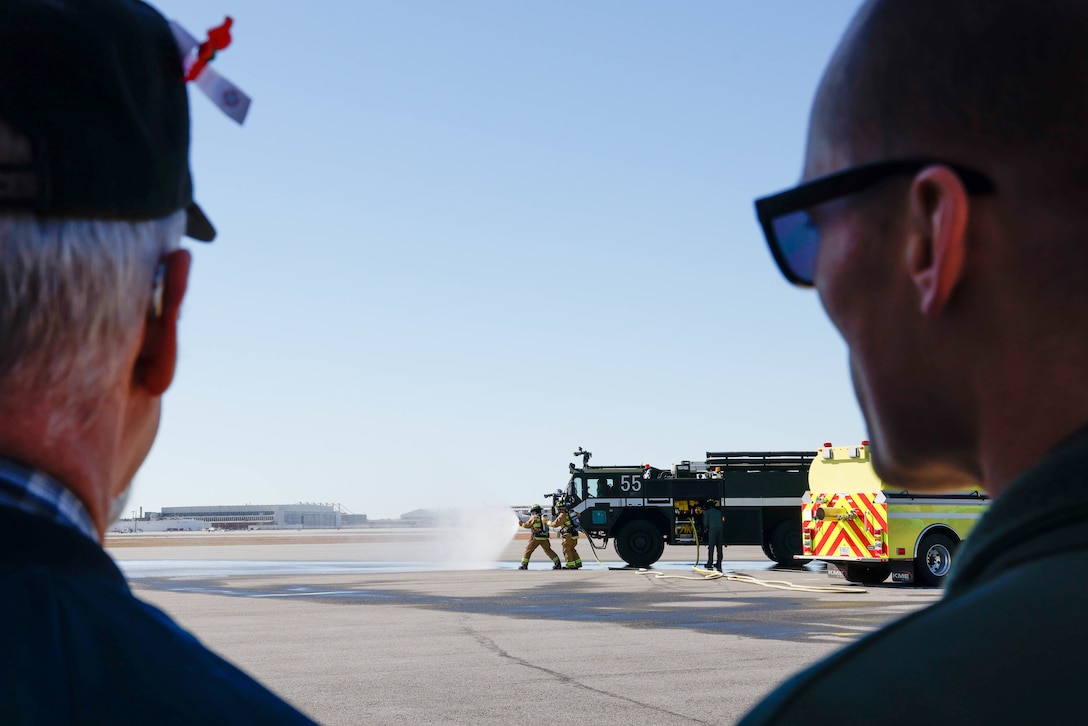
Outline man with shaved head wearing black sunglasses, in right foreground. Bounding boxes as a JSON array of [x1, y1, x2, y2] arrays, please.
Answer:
[[743, 0, 1088, 725]]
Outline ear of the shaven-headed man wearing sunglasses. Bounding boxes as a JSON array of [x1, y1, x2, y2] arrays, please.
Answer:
[[908, 167, 969, 317]]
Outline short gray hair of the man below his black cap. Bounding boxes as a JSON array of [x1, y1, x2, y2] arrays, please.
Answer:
[[0, 124, 185, 428]]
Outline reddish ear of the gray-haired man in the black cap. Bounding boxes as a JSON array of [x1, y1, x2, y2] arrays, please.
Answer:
[[133, 249, 193, 396]]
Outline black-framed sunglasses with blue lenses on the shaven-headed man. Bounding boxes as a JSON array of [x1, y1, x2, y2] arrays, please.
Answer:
[[755, 158, 994, 287]]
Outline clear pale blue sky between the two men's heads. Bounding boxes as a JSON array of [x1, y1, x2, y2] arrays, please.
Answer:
[[138, 0, 865, 518]]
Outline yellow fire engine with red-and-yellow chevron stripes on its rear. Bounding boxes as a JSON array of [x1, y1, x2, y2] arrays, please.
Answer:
[[800, 441, 990, 586]]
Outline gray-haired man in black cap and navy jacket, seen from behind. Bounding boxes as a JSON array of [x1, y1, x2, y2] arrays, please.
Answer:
[[0, 0, 310, 724]]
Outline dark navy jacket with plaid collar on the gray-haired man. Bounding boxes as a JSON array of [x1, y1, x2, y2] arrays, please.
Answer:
[[0, 463, 313, 726]]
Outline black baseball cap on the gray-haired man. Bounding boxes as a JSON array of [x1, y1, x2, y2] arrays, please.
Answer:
[[0, 0, 215, 242]]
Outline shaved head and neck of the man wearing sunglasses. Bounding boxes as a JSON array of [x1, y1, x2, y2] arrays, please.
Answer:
[[792, 0, 1088, 493]]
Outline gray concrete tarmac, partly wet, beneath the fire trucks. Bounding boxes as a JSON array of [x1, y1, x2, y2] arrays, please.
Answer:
[[107, 532, 939, 726]]
